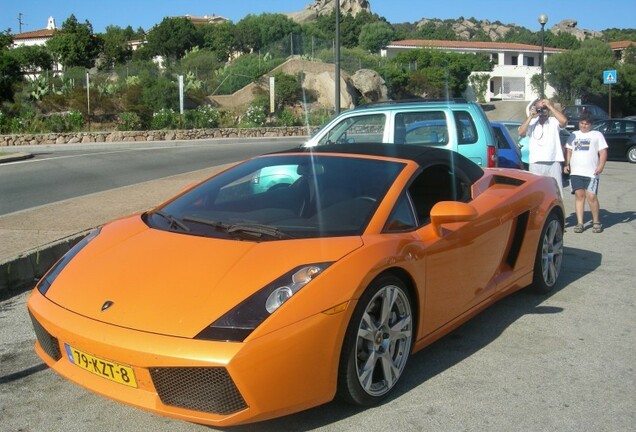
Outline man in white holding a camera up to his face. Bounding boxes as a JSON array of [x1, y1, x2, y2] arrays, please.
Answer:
[[519, 99, 568, 196]]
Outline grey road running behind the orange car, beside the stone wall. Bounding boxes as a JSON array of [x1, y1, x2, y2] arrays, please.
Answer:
[[0, 137, 305, 216]]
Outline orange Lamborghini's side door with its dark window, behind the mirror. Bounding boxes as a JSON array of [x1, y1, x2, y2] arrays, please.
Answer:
[[409, 165, 512, 334]]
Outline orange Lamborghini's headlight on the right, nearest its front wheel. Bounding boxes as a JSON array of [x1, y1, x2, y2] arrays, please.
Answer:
[[195, 263, 331, 342]]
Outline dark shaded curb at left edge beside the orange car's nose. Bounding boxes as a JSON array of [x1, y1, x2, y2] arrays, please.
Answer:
[[0, 230, 92, 299]]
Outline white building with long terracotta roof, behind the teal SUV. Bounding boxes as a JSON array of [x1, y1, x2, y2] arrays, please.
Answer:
[[382, 39, 565, 101]]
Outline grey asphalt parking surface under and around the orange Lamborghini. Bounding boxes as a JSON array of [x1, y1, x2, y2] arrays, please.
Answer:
[[0, 162, 636, 432]]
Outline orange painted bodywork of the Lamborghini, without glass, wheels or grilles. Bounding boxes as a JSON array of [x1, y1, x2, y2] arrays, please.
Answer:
[[28, 150, 562, 426]]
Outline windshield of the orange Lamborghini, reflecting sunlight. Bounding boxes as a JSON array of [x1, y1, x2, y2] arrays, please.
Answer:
[[144, 154, 405, 241]]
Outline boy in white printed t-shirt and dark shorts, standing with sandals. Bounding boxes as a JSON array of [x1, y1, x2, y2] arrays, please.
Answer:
[[563, 112, 607, 233]]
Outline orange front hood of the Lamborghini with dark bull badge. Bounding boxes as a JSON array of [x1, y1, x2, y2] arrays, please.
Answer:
[[46, 216, 362, 338]]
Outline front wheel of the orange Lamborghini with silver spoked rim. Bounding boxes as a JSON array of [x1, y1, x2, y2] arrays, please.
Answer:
[[337, 275, 414, 406]]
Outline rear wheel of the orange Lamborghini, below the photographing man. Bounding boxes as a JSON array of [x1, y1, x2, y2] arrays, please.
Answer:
[[532, 213, 563, 294]]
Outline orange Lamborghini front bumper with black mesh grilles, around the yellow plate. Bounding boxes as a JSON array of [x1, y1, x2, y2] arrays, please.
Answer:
[[28, 290, 352, 426]]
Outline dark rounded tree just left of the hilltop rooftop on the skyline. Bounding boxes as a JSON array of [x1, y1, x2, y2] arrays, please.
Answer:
[[146, 17, 203, 60]]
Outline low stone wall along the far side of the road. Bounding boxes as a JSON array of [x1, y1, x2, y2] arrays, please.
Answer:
[[0, 126, 318, 148]]
